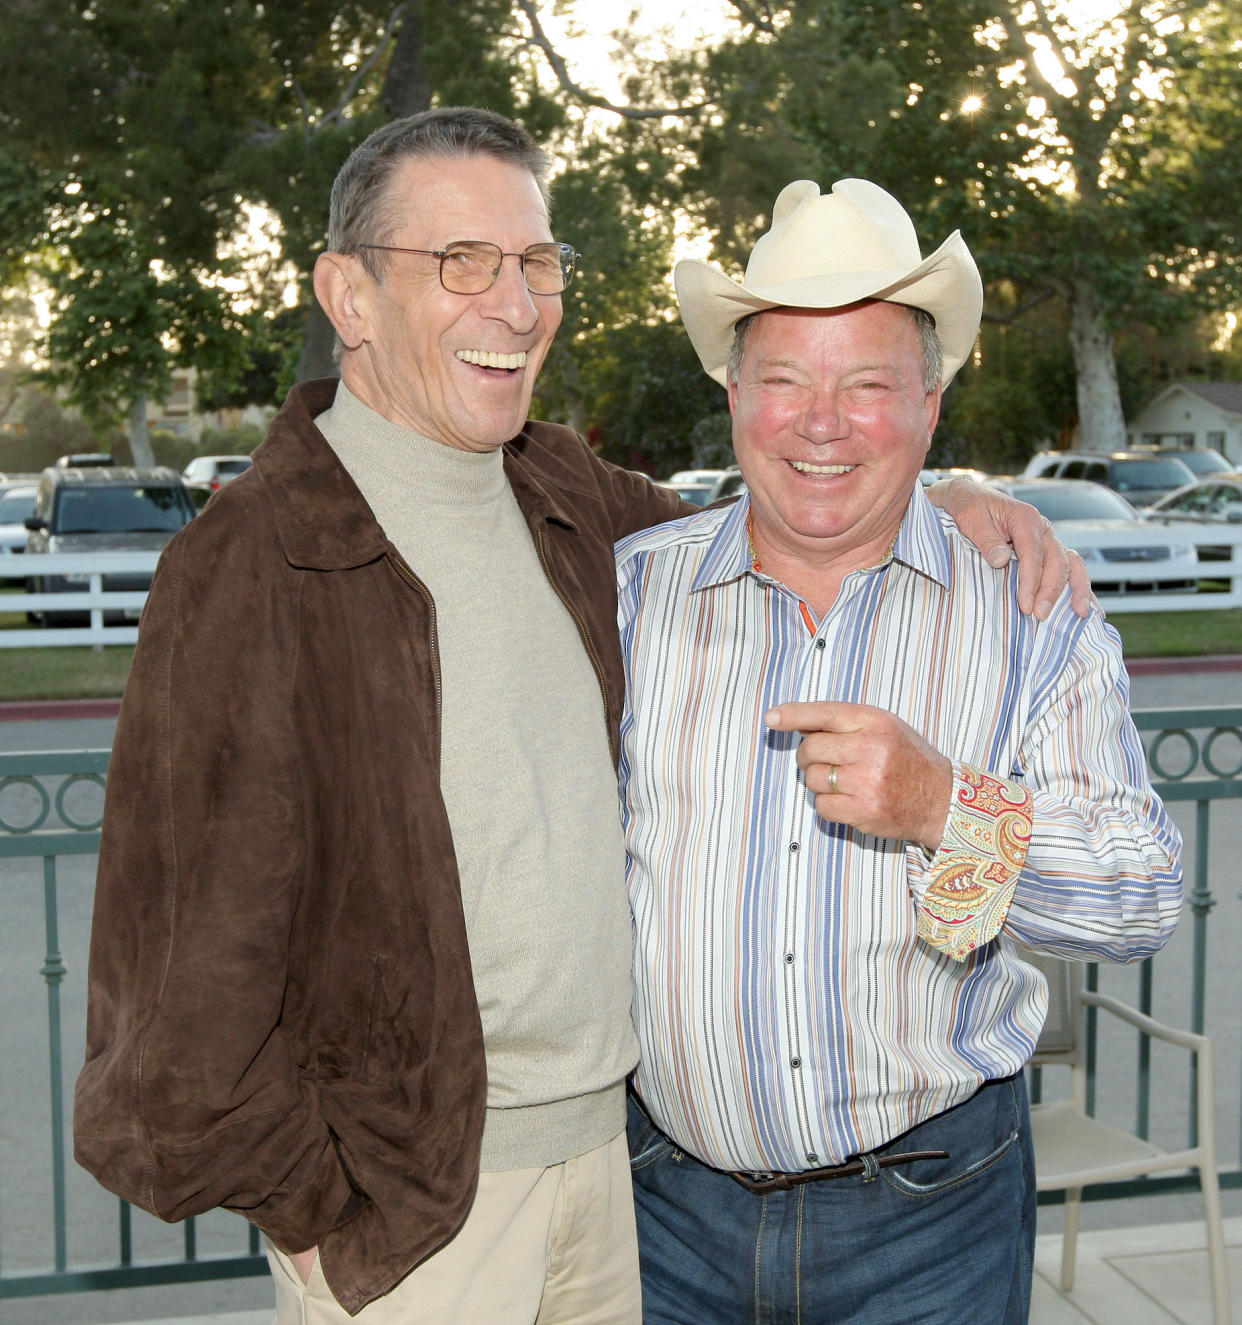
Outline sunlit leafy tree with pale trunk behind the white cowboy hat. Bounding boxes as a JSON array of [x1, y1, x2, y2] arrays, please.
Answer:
[[673, 0, 1242, 448]]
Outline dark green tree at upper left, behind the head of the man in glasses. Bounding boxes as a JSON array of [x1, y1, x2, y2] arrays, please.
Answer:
[[0, 0, 557, 417]]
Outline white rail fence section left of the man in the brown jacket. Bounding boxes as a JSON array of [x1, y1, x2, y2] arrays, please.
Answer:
[[0, 553, 159, 649]]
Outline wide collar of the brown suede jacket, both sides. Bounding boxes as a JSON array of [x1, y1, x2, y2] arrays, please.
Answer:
[[254, 378, 585, 571]]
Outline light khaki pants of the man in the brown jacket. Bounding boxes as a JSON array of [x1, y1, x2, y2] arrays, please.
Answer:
[[268, 1133, 642, 1325]]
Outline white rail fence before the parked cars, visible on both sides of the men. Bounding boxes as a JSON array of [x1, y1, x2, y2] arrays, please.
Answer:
[[0, 525, 1242, 648]]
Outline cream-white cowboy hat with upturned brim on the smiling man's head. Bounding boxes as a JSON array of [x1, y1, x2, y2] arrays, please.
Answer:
[[673, 179, 984, 386]]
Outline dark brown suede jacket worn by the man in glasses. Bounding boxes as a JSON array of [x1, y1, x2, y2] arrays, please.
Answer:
[[74, 382, 688, 1314]]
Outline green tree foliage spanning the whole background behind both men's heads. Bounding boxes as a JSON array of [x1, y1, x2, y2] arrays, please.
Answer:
[[0, 0, 1242, 469]]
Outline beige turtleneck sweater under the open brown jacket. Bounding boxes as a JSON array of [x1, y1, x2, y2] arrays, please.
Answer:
[[315, 383, 638, 1169]]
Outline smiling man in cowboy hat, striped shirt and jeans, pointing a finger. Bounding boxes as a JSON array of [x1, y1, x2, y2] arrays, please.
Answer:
[[618, 180, 1181, 1325]]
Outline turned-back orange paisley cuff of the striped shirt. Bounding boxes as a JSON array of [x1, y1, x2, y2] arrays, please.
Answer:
[[915, 763, 1033, 962]]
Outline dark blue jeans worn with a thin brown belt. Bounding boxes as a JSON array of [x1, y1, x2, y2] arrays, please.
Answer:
[[628, 1073, 1035, 1325]]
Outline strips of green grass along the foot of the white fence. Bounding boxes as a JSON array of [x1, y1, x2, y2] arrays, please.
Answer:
[[0, 608, 1242, 702]]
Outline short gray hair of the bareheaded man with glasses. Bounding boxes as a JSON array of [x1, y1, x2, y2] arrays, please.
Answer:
[[327, 106, 551, 281]]
